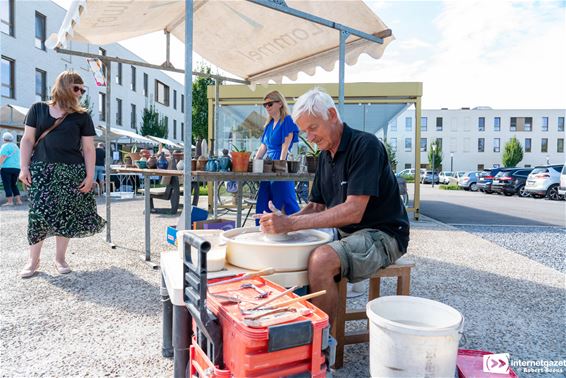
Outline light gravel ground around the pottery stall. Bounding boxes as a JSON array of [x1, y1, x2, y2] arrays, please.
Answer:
[[0, 200, 566, 377]]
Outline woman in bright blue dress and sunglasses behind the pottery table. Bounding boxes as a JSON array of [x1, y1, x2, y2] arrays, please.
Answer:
[[255, 91, 299, 220]]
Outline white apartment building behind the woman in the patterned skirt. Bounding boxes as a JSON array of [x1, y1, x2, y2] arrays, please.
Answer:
[[0, 0, 184, 141]]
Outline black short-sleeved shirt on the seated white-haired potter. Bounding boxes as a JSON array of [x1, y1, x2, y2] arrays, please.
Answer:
[[310, 123, 409, 252]]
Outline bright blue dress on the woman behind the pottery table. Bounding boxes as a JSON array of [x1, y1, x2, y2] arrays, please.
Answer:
[[256, 116, 299, 220]]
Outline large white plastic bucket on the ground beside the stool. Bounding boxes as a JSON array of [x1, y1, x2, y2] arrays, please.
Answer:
[[366, 295, 464, 377]]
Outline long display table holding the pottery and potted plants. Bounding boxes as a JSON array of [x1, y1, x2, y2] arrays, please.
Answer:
[[112, 168, 314, 261]]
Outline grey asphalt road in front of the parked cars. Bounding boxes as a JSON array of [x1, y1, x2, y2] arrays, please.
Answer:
[[418, 185, 566, 227]]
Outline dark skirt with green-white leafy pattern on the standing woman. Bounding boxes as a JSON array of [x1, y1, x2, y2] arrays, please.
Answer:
[[28, 161, 106, 245]]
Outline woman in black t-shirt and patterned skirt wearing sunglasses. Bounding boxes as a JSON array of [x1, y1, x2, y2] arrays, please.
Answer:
[[20, 71, 106, 278]]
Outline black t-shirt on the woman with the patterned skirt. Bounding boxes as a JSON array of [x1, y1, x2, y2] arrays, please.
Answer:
[[24, 102, 96, 164]]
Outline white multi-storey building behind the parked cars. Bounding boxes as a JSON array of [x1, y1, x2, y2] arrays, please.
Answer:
[[387, 107, 566, 171]]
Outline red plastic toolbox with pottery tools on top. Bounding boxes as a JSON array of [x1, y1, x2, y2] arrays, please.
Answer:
[[207, 277, 328, 378]]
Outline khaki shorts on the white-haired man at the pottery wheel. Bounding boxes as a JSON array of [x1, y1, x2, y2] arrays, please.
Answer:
[[328, 229, 403, 283]]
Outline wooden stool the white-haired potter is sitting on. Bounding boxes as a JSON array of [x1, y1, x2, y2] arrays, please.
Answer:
[[332, 257, 415, 369]]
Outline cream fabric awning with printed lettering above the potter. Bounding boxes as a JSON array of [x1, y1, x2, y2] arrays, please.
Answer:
[[48, 0, 394, 83]]
